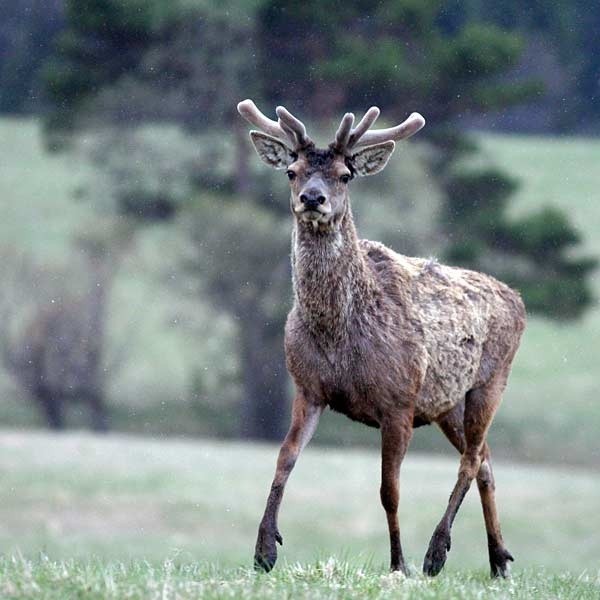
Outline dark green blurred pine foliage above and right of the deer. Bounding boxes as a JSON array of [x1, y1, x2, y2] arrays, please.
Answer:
[[260, 0, 596, 318]]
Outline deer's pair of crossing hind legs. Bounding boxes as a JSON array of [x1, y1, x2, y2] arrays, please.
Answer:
[[423, 376, 512, 576]]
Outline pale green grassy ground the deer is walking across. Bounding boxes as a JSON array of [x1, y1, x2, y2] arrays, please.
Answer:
[[0, 431, 600, 599]]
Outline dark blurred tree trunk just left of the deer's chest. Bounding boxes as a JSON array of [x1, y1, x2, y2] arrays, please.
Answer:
[[240, 310, 290, 441]]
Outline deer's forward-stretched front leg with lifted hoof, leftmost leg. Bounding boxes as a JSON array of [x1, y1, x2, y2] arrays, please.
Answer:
[[254, 392, 323, 572]]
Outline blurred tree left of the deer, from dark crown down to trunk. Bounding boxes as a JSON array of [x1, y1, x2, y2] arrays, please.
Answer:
[[45, 0, 289, 438]]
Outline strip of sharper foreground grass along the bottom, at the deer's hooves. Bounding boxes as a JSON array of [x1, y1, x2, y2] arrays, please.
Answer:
[[0, 557, 600, 600]]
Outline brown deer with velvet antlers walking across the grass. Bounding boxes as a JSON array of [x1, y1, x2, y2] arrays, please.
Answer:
[[237, 99, 526, 577]]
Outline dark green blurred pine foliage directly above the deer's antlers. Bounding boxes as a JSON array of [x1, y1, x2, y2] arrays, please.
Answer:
[[260, 0, 536, 118]]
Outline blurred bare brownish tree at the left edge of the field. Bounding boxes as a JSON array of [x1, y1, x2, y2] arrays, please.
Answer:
[[0, 230, 131, 431]]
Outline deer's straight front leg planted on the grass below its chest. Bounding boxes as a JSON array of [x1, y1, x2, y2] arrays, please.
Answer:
[[380, 411, 412, 575]]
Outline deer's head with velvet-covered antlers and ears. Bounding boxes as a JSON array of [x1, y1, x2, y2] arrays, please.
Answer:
[[237, 100, 425, 231]]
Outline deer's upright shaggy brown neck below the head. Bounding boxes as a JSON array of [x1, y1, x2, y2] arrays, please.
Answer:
[[292, 208, 374, 344]]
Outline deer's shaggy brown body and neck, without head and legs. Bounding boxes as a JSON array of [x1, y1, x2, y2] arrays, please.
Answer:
[[285, 210, 524, 427]]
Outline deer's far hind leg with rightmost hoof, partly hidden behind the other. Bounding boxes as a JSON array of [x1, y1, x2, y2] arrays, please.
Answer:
[[438, 403, 514, 577]]
